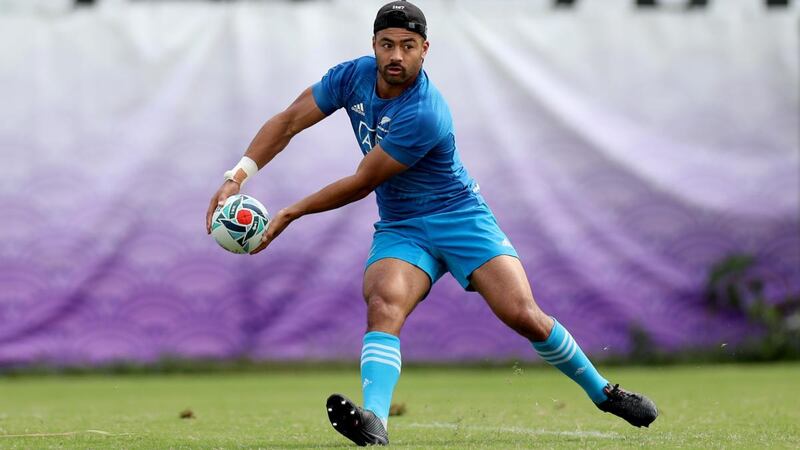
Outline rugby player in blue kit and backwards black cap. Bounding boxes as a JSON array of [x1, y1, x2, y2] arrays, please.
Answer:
[[206, 1, 658, 445]]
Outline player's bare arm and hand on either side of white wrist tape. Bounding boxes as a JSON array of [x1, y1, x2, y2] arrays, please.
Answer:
[[206, 88, 325, 233]]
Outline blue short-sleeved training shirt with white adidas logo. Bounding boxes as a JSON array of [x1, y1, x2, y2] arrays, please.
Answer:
[[312, 56, 483, 221]]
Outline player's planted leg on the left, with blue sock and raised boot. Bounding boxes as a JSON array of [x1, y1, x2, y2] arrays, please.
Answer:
[[327, 258, 431, 445]]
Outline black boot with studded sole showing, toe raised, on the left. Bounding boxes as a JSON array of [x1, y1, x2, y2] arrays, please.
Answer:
[[326, 394, 389, 447]]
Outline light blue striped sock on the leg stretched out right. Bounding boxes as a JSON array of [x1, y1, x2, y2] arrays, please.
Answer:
[[531, 318, 608, 403]]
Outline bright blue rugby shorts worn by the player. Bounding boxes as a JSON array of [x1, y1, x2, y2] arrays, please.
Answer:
[[367, 204, 518, 291]]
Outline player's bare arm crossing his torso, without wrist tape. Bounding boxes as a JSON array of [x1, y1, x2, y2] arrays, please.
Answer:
[[253, 144, 408, 253]]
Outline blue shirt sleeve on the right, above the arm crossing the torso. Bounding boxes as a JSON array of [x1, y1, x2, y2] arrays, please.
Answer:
[[380, 108, 443, 167]]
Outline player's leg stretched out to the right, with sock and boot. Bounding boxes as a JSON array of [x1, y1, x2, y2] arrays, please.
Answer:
[[470, 255, 657, 426]]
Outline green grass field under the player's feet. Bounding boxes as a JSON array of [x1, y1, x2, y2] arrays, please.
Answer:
[[0, 364, 800, 449]]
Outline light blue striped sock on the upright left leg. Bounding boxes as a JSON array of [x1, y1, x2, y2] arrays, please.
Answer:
[[361, 331, 402, 431]]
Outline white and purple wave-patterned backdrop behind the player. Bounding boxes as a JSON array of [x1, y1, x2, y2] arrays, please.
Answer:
[[0, 2, 800, 364]]
